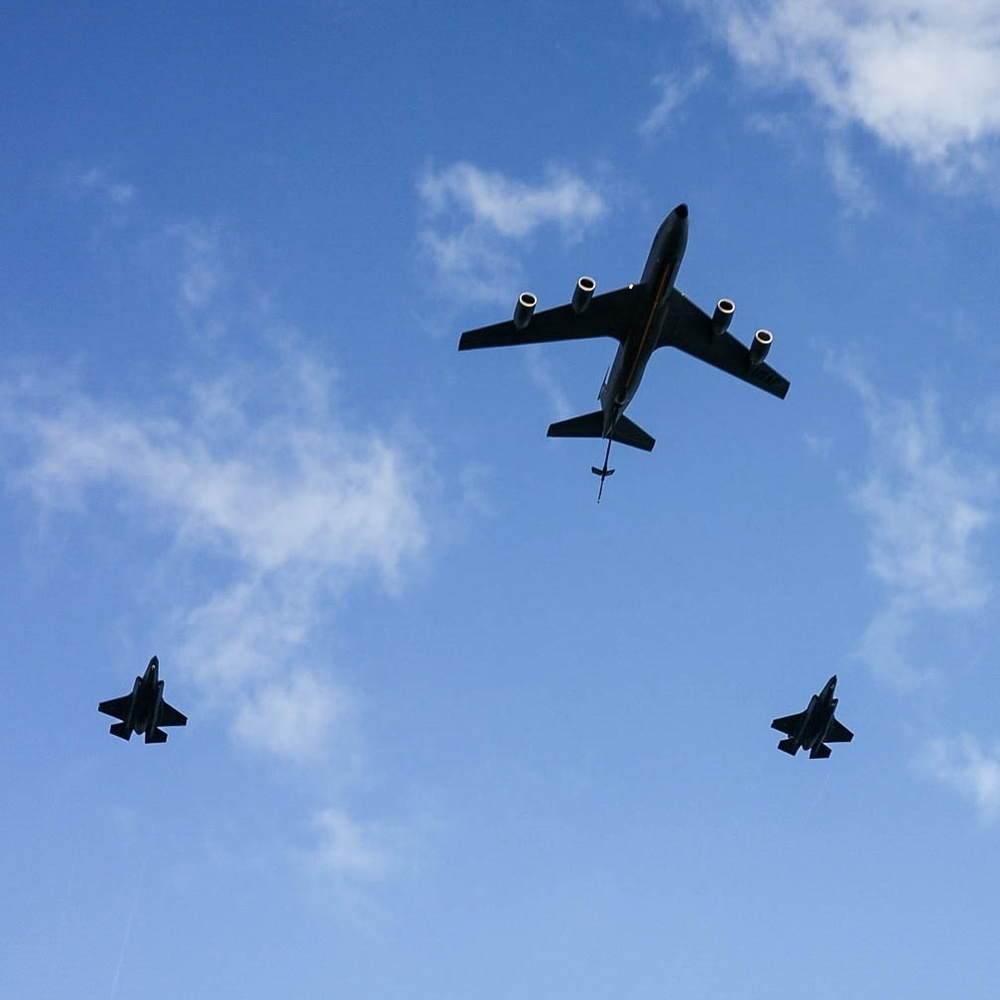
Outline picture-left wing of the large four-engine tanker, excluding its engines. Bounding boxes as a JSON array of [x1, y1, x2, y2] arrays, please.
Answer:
[[458, 285, 644, 351]]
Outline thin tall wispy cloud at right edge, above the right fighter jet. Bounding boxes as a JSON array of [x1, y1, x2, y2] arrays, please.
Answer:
[[840, 367, 997, 683]]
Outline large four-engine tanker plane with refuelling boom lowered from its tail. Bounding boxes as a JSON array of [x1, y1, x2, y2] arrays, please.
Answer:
[[458, 204, 789, 501]]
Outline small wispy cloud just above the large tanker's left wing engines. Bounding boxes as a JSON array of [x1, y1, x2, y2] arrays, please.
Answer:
[[417, 162, 607, 302]]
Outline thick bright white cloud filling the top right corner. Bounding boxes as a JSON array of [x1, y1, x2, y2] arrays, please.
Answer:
[[694, 0, 1000, 180]]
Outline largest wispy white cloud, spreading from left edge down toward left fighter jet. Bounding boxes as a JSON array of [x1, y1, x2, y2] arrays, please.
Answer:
[[0, 356, 428, 760]]
